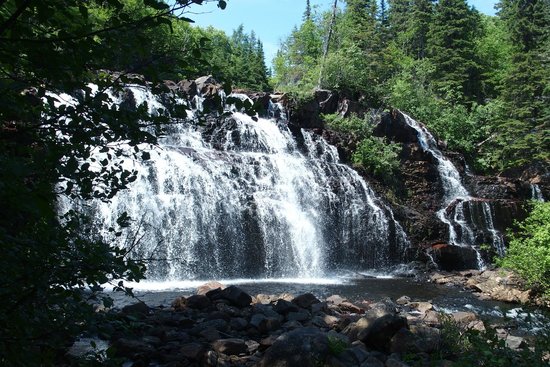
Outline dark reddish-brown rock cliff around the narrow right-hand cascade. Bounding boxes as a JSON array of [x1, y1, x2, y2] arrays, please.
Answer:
[[289, 91, 550, 270]]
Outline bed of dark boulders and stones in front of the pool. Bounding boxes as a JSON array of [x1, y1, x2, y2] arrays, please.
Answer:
[[72, 272, 548, 367]]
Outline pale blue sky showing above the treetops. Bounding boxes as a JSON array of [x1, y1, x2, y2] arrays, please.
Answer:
[[185, 0, 497, 66]]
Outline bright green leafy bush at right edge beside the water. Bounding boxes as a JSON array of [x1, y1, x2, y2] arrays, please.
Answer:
[[499, 202, 550, 298]]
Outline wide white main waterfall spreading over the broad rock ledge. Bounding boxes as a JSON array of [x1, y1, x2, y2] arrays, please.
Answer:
[[61, 86, 409, 281]]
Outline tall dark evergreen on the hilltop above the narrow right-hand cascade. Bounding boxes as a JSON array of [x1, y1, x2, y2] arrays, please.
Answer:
[[428, 0, 480, 102]]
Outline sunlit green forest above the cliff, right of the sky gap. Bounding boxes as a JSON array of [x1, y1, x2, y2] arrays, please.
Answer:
[[273, 0, 550, 172]]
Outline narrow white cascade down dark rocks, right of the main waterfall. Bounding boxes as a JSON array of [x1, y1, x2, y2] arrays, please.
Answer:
[[403, 114, 505, 269]]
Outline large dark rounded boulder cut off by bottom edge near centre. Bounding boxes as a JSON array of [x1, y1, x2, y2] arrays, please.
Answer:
[[259, 328, 329, 367]]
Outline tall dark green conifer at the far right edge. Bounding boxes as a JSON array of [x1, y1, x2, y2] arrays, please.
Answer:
[[497, 0, 550, 167]]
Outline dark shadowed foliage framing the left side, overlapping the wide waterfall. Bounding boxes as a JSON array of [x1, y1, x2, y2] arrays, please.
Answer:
[[0, 0, 232, 366]]
